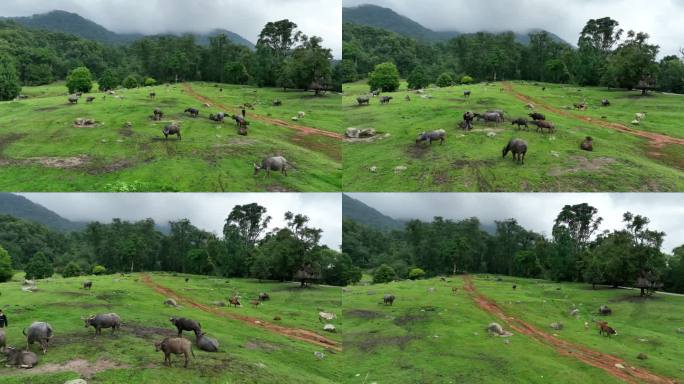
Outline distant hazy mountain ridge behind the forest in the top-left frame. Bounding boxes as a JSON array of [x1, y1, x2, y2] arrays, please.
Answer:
[[8, 10, 254, 49]]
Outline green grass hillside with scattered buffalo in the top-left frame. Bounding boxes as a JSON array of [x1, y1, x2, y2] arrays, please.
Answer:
[[0, 83, 342, 192]]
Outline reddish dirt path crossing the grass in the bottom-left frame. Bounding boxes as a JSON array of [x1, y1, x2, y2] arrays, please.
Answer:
[[142, 275, 342, 351]]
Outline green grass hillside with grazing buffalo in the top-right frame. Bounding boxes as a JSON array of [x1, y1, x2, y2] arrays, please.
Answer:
[[342, 82, 684, 192]]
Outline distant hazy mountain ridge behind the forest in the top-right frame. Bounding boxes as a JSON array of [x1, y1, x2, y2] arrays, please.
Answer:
[[342, 5, 567, 44]]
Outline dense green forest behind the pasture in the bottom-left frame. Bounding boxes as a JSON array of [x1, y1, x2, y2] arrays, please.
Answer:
[[0, 203, 361, 285]]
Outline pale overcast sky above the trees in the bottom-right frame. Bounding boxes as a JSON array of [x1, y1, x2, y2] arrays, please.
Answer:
[[348, 193, 684, 253]]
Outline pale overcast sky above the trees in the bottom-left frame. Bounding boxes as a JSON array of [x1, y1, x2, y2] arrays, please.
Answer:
[[20, 193, 342, 249]]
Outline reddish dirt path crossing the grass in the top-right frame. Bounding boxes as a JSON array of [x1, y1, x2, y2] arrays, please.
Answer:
[[502, 81, 684, 148]]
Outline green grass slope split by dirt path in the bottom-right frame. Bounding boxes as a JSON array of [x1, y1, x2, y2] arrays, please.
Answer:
[[342, 276, 684, 383]]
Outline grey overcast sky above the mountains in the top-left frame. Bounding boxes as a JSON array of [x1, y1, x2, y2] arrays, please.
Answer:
[[0, 0, 342, 58]]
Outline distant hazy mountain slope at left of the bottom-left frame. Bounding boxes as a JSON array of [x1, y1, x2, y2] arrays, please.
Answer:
[[0, 193, 86, 232]]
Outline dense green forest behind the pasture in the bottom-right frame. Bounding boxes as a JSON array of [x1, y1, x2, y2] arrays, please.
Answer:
[[342, 204, 684, 294]]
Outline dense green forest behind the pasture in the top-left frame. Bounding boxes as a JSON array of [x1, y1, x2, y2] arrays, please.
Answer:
[[0, 20, 341, 100]]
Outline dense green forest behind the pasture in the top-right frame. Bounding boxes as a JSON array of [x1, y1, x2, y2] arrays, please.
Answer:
[[341, 17, 684, 93]]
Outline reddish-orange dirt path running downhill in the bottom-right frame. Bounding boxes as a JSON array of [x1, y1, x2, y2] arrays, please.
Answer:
[[463, 276, 677, 384]]
